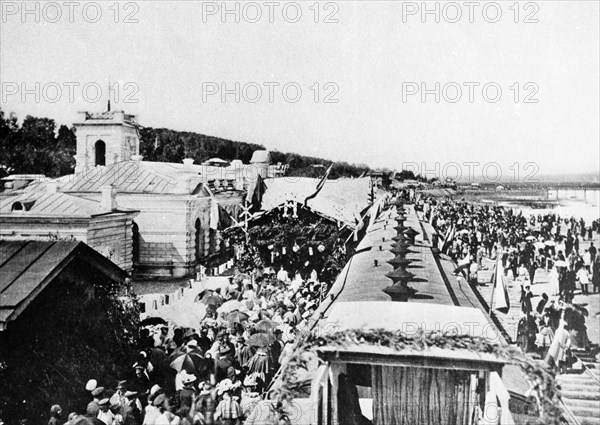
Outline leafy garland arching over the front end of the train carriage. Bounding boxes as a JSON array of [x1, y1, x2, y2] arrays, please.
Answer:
[[273, 329, 562, 425]]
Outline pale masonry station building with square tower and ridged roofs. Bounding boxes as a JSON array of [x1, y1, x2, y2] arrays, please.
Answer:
[[0, 111, 270, 279]]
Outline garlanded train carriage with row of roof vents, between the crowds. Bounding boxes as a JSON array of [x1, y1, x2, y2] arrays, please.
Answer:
[[245, 201, 540, 425]]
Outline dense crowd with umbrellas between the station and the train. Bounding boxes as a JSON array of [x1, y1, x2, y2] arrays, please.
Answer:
[[45, 267, 327, 425]]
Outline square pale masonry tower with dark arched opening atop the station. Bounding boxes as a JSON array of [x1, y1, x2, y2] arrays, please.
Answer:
[[73, 108, 142, 173]]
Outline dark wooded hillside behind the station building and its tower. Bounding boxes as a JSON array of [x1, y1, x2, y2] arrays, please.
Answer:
[[0, 108, 371, 179]]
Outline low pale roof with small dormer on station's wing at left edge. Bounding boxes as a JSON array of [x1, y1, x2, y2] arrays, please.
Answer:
[[0, 190, 106, 217]]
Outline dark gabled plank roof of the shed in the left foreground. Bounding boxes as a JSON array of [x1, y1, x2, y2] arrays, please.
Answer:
[[0, 241, 127, 330]]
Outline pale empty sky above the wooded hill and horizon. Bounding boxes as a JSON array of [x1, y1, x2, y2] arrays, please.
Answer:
[[0, 0, 600, 181]]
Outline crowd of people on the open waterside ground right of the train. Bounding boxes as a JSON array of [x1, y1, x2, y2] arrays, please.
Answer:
[[417, 198, 600, 370]]
